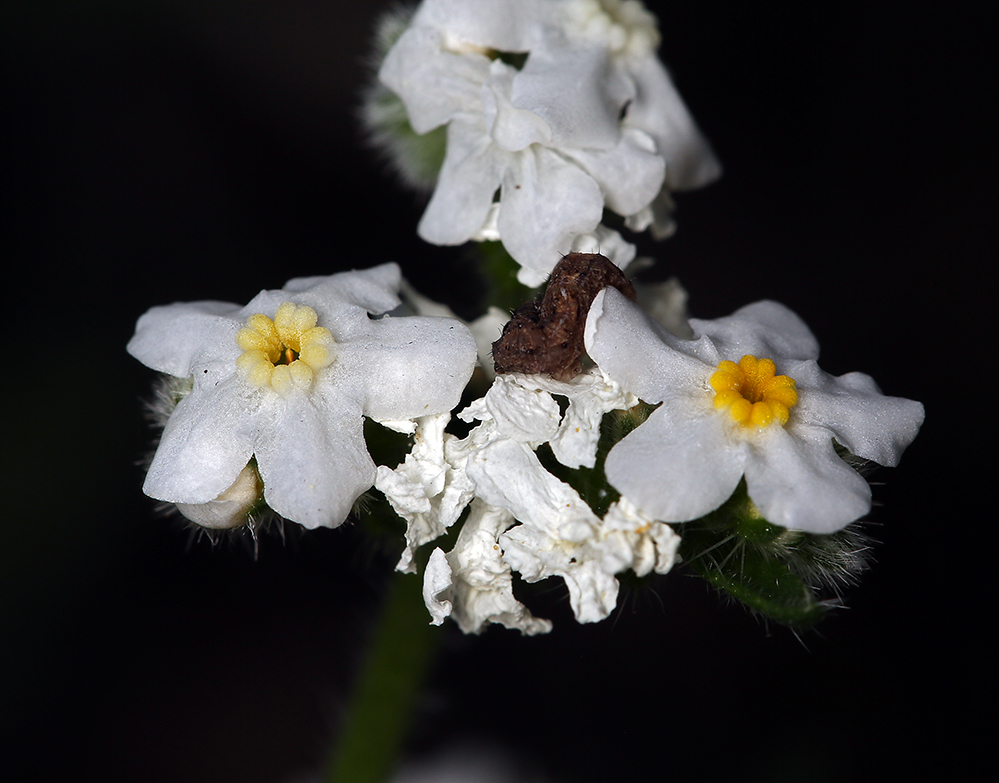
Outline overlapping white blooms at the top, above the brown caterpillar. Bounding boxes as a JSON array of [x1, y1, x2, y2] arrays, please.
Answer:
[[379, 0, 719, 286]]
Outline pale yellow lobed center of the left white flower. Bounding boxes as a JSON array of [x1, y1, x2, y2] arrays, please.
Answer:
[[236, 302, 335, 394]]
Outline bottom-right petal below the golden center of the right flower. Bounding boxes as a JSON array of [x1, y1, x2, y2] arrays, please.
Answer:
[[746, 427, 871, 533]]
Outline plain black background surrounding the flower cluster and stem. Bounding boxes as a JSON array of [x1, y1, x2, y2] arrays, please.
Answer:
[[0, 0, 997, 783]]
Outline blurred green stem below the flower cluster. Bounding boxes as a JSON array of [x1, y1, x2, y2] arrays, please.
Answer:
[[323, 573, 441, 783]]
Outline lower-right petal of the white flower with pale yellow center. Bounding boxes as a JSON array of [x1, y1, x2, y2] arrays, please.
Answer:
[[256, 390, 375, 528]]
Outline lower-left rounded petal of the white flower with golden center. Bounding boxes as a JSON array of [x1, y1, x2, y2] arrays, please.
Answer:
[[604, 401, 747, 522]]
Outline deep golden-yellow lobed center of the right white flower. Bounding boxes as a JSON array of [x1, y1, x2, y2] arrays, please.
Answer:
[[710, 354, 798, 427]]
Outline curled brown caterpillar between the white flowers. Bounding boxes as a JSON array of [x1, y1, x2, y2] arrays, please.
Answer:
[[493, 253, 636, 381]]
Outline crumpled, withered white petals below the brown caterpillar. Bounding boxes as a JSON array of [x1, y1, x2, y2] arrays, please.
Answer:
[[378, 368, 679, 633]]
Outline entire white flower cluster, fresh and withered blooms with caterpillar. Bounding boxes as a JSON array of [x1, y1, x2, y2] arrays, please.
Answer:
[[128, 0, 923, 634]]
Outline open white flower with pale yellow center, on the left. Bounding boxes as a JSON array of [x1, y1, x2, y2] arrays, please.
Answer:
[[128, 264, 475, 528]]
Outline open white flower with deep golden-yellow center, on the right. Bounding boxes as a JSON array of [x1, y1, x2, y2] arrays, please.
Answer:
[[585, 289, 923, 533]]
